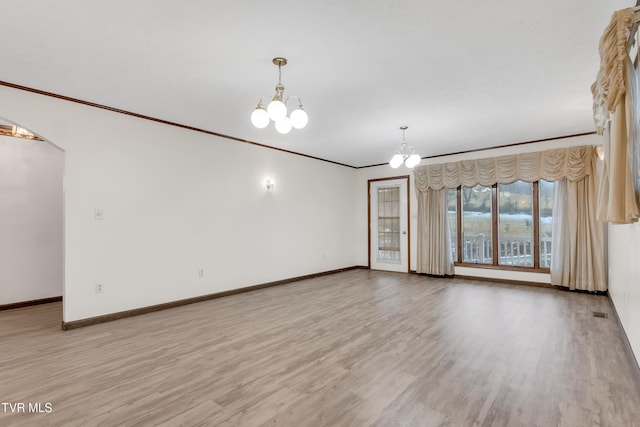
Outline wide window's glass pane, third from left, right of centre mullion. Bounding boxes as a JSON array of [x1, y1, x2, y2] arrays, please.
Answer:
[[498, 181, 533, 267]]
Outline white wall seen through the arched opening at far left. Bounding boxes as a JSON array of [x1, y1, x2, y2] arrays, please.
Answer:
[[0, 136, 64, 305]]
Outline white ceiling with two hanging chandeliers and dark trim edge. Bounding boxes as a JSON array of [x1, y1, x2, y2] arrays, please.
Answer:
[[0, 0, 633, 167]]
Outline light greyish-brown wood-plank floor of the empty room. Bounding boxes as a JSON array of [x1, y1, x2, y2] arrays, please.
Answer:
[[0, 270, 640, 427]]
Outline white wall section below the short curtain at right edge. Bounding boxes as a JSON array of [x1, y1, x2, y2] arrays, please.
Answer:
[[608, 223, 640, 363]]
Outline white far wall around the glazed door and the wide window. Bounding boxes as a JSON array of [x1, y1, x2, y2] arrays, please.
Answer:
[[356, 135, 601, 283]]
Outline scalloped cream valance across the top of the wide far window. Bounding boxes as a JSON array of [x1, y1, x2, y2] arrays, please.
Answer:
[[414, 146, 593, 191]]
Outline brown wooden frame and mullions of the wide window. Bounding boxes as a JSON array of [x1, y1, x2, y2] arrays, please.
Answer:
[[454, 181, 553, 273]]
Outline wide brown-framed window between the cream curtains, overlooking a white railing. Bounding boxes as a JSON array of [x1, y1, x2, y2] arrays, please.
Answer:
[[447, 181, 553, 270]]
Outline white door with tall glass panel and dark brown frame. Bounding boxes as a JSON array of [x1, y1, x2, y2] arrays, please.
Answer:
[[369, 176, 409, 273]]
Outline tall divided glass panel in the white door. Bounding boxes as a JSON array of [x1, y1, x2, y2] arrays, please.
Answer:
[[378, 187, 400, 262]]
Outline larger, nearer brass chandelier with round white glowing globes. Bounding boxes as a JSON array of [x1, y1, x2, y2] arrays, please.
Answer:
[[251, 57, 309, 134]]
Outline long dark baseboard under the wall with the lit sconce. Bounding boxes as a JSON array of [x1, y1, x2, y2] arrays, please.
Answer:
[[62, 265, 368, 331]]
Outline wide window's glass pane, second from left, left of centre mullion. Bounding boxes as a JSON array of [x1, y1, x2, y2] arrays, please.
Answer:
[[462, 185, 493, 264]]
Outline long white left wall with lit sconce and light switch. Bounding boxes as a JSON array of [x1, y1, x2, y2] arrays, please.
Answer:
[[0, 87, 357, 322]]
